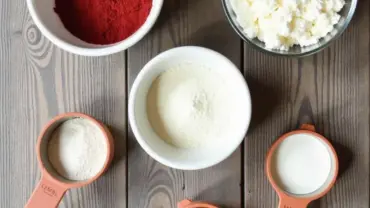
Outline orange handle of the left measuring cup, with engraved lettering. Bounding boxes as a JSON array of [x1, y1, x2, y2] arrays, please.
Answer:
[[25, 176, 67, 208]]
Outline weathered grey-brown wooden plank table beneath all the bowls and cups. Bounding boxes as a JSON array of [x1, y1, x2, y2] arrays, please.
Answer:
[[0, 0, 370, 208]]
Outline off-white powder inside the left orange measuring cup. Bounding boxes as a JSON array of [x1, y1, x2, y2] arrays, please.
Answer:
[[48, 118, 107, 181]]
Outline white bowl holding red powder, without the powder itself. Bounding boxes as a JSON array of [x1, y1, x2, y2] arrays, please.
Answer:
[[27, 0, 163, 56]]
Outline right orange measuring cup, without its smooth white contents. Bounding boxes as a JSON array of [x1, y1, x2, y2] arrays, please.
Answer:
[[265, 124, 339, 208]]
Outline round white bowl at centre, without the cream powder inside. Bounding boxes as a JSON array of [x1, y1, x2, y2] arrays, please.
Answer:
[[128, 46, 251, 170]]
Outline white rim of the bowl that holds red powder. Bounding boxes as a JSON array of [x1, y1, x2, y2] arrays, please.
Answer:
[[27, 0, 164, 56]]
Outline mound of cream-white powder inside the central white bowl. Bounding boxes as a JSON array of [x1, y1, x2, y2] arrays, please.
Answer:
[[147, 62, 241, 148]]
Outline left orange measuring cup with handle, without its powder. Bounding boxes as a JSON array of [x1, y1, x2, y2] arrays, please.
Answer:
[[25, 113, 114, 208]]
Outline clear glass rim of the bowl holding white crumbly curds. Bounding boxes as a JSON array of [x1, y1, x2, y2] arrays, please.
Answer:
[[221, 0, 357, 57]]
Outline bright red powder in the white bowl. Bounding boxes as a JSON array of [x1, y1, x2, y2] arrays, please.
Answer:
[[54, 0, 152, 45]]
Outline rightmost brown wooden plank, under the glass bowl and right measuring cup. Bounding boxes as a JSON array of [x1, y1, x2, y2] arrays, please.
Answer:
[[244, 0, 370, 208]]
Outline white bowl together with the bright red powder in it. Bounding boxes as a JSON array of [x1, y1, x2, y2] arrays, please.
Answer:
[[27, 0, 163, 56]]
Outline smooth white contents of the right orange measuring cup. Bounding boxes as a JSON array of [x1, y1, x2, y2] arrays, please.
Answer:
[[272, 134, 331, 194]]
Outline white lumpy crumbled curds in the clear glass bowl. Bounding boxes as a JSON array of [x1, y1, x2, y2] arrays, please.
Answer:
[[230, 0, 345, 50]]
